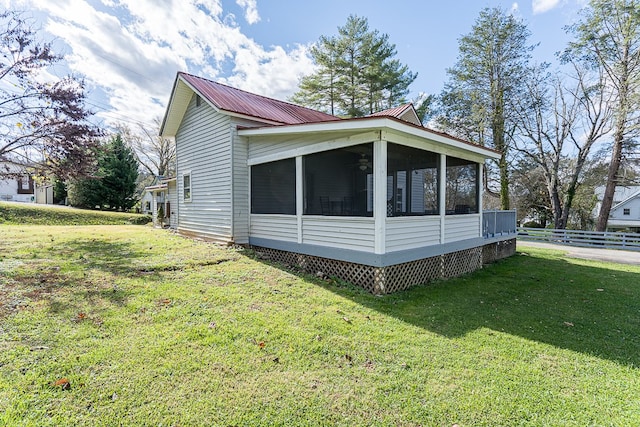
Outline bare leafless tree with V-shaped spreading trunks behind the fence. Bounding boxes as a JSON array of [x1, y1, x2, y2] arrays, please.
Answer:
[[517, 64, 613, 229]]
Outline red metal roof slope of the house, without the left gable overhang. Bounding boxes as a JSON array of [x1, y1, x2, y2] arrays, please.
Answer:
[[178, 72, 340, 125]]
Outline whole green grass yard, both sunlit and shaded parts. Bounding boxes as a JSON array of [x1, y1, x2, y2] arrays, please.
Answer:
[[0, 225, 640, 427]]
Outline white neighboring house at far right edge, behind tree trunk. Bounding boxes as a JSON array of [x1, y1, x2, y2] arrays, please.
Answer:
[[594, 186, 640, 233]]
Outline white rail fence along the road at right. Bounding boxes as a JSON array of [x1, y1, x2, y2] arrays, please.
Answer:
[[518, 227, 640, 251]]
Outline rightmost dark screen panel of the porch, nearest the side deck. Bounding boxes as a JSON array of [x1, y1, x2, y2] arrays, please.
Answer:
[[445, 156, 478, 215]]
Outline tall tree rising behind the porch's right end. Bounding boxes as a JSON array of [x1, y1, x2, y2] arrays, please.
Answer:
[[438, 8, 533, 209]]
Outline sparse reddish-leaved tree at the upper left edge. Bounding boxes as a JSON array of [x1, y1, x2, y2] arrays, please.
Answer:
[[0, 11, 100, 178]]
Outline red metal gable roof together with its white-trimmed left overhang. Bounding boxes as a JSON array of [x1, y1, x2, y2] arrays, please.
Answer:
[[161, 72, 340, 135]]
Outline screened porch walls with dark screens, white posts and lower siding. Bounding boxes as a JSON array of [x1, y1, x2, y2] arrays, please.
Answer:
[[250, 141, 481, 254]]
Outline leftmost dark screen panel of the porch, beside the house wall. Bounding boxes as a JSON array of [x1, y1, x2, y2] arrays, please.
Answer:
[[251, 159, 296, 215]]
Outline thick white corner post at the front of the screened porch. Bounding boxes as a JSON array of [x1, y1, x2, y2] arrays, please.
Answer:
[[373, 140, 387, 254]]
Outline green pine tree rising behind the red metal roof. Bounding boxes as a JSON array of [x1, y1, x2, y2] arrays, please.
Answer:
[[291, 15, 417, 117]]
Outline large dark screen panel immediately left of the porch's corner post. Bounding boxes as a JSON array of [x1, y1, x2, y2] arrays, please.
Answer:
[[303, 144, 373, 216]]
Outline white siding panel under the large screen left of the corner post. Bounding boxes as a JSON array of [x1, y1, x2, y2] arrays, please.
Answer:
[[302, 216, 374, 253]]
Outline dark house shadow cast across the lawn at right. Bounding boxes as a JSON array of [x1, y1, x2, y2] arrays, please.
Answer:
[[258, 252, 640, 367]]
